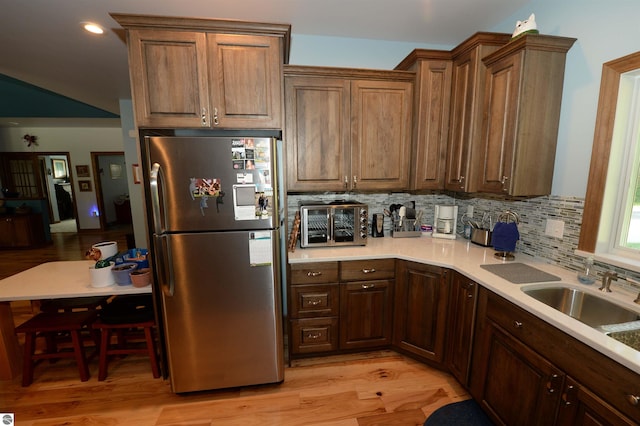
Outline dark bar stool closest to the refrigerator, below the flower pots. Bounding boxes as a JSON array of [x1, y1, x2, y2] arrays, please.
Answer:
[[93, 294, 160, 380]]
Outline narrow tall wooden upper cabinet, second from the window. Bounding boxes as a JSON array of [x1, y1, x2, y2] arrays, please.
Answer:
[[444, 33, 511, 192]]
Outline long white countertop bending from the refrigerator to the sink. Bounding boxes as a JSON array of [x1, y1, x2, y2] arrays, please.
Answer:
[[289, 236, 640, 374]]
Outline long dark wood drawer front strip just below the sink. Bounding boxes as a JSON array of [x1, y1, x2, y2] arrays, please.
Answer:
[[483, 291, 640, 423]]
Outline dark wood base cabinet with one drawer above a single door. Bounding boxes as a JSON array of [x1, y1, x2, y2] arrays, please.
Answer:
[[340, 259, 395, 350]]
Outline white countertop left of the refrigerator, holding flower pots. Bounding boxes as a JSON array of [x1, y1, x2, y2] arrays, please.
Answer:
[[0, 260, 151, 302]]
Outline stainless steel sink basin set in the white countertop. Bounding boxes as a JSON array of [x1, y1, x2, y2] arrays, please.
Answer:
[[522, 286, 640, 332]]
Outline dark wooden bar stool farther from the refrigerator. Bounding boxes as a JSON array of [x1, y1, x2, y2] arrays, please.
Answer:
[[16, 310, 98, 386]]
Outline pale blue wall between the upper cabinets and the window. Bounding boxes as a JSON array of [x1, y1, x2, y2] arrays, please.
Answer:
[[492, 0, 640, 197]]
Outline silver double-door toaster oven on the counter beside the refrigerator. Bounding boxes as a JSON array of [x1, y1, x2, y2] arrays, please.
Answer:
[[300, 201, 369, 248]]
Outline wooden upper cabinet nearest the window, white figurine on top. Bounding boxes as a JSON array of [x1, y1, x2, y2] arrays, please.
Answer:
[[477, 35, 575, 196]]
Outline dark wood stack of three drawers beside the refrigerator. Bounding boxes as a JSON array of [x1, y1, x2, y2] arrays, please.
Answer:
[[289, 262, 340, 357]]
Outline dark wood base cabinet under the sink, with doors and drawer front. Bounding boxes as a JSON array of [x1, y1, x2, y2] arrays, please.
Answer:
[[470, 288, 640, 425]]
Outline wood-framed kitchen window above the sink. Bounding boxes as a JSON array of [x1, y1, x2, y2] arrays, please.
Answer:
[[578, 52, 640, 272]]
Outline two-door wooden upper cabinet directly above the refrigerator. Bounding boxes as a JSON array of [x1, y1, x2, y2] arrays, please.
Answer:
[[112, 14, 291, 129]]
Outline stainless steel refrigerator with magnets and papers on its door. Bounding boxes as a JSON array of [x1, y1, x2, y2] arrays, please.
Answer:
[[143, 136, 284, 393]]
